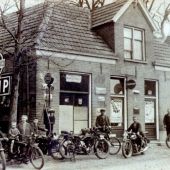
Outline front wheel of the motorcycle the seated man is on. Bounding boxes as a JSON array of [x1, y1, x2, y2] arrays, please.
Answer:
[[122, 140, 133, 158]]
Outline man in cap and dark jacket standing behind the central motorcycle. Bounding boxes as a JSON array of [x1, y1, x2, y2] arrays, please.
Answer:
[[96, 109, 110, 131]]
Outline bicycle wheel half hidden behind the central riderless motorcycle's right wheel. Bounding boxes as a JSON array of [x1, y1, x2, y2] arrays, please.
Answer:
[[109, 137, 121, 155]]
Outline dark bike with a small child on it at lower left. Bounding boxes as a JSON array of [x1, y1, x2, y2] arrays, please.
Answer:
[[2, 135, 44, 169]]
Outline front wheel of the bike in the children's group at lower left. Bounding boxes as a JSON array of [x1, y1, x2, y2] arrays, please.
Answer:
[[30, 147, 44, 169]]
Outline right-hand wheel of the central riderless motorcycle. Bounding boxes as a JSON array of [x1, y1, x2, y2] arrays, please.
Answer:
[[94, 139, 110, 159]]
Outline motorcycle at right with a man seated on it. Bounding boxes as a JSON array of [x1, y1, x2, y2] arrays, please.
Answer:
[[122, 131, 149, 158]]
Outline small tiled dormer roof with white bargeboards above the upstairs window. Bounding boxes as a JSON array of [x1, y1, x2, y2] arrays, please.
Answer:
[[92, 0, 158, 31]]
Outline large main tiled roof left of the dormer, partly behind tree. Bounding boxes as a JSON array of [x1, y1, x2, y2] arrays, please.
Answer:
[[0, 3, 114, 59]]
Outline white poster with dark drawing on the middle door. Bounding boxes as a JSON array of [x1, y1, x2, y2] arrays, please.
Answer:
[[110, 99, 123, 123]]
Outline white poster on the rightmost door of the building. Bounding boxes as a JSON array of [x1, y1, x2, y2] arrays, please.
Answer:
[[145, 101, 155, 123]]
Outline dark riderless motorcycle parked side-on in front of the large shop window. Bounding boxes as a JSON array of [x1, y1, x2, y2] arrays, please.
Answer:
[[60, 128, 109, 159]]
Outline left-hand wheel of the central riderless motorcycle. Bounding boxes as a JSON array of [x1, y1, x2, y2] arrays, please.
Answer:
[[59, 140, 75, 159]]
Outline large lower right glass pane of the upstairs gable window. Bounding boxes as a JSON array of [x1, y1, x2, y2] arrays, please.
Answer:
[[133, 41, 142, 60]]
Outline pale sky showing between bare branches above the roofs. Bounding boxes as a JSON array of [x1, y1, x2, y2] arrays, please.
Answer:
[[0, 0, 170, 35]]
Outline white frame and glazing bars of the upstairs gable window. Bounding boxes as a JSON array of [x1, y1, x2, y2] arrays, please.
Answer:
[[123, 26, 146, 61]]
